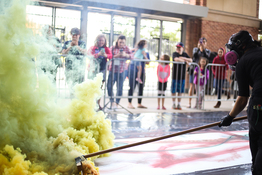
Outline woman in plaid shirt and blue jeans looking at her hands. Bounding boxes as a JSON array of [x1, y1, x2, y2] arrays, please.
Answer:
[[107, 35, 133, 108]]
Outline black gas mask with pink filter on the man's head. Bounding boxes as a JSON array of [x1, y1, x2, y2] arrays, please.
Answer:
[[225, 31, 254, 71]]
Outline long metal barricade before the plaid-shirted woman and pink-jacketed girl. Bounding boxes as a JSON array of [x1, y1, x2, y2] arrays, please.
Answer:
[[104, 58, 199, 108]]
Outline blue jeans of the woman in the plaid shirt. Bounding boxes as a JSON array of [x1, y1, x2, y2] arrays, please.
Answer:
[[107, 71, 125, 104]]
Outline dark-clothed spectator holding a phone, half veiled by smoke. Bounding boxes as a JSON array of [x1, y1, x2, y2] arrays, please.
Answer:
[[62, 28, 87, 95]]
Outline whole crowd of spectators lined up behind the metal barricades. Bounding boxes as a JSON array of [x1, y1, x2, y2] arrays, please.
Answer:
[[45, 28, 237, 110]]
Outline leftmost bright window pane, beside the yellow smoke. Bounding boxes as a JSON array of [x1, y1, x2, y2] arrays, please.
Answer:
[[26, 5, 52, 33]]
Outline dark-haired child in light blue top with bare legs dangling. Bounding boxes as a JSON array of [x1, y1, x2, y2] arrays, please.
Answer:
[[134, 40, 148, 84]]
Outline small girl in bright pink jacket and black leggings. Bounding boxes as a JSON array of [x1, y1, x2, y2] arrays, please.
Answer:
[[157, 55, 170, 110]]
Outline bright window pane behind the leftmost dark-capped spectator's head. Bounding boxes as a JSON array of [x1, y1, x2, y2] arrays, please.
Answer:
[[55, 8, 80, 42]]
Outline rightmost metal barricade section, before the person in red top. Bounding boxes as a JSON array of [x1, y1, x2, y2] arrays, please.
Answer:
[[204, 64, 238, 108]]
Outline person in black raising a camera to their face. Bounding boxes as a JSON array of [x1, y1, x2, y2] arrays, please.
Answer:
[[188, 37, 213, 108]]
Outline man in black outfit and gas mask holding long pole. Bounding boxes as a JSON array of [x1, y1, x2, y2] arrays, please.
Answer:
[[219, 30, 262, 175]]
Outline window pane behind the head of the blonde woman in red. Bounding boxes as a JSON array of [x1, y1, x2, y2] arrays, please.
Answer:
[[87, 12, 111, 48]]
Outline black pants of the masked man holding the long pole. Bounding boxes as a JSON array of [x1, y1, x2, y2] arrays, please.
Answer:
[[247, 96, 262, 175]]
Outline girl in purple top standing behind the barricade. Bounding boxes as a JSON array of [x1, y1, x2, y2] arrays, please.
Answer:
[[194, 57, 209, 109]]
